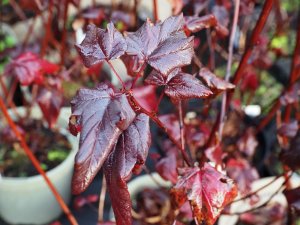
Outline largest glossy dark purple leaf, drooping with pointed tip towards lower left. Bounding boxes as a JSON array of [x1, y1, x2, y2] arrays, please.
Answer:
[[71, 84, 135, 194]]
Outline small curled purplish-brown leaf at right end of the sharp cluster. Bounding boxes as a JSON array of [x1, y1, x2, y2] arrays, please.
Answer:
[[199, 68, 235, 92]]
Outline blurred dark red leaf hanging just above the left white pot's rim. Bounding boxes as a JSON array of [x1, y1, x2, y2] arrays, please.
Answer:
[[37, 87, 63, 128]]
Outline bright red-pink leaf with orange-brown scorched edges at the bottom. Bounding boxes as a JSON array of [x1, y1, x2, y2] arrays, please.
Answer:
[[171, 163, 237, 225]]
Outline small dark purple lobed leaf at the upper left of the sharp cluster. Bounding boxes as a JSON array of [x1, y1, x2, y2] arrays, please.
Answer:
[[76, 23, 126, 67]]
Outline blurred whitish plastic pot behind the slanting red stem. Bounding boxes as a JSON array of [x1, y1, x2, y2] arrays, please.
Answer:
[[0, 108, 78, 224]]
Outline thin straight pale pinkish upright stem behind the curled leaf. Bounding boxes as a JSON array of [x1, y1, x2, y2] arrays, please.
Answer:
[[219, 0, 240, 141]]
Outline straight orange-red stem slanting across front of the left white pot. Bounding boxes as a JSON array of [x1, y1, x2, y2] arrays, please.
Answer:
[[0, 98, 78, 225]]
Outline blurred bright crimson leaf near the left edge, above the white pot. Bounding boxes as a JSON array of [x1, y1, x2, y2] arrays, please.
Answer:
[[5, 52, 58, 86]]
